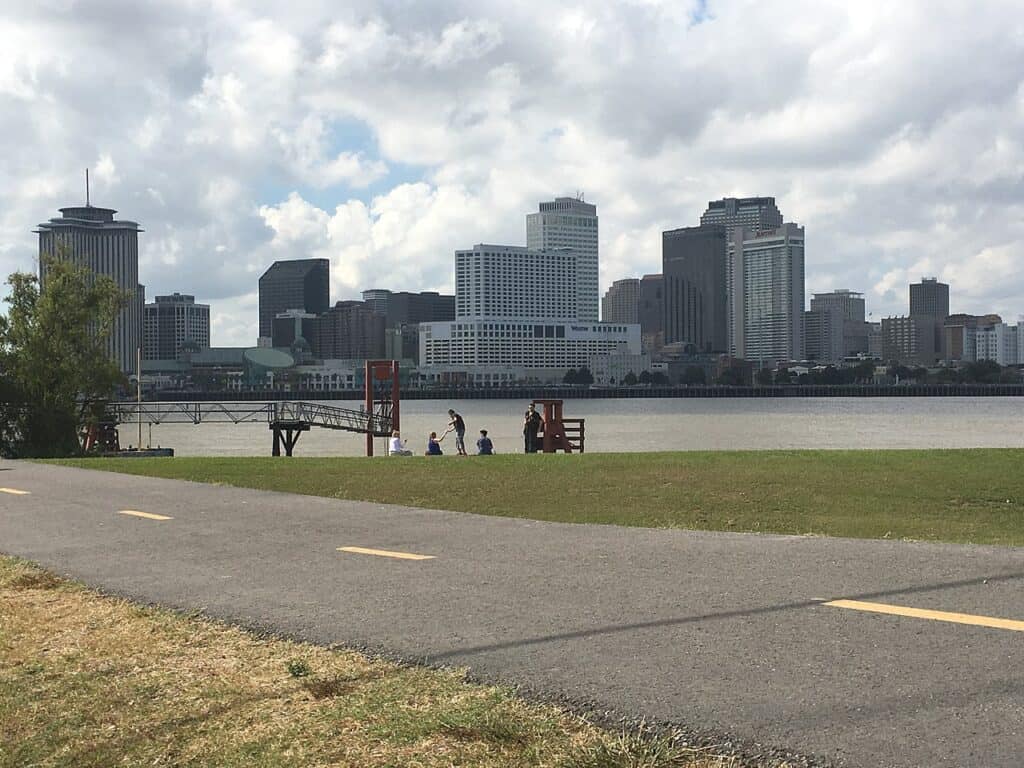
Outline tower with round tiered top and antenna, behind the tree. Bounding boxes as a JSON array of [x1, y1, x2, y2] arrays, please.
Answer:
[[35, 199, 145, 374]]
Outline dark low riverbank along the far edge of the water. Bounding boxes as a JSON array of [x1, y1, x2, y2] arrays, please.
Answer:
[[145, 384, 1024, 401]]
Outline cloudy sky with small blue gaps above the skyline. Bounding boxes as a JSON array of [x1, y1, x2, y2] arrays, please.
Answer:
[[0, 0, 1024, 345]]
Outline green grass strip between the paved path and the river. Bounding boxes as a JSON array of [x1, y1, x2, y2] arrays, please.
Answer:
[[49, 450, 1024, 546]]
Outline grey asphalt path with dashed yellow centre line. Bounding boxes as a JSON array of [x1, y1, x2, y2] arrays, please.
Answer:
[[0, 462, 1024, 768]]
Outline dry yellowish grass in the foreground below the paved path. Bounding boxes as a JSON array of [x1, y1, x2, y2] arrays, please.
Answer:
[[0, 557, 753, 768]]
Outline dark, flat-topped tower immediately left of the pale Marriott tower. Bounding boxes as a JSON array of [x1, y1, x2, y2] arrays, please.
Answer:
[[662, 224, 728, 352]]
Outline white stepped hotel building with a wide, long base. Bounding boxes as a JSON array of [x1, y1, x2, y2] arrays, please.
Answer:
[[420, 245, 640, 383]]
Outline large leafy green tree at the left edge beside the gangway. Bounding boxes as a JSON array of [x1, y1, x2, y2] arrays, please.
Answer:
[[0, 251, 128, 457]]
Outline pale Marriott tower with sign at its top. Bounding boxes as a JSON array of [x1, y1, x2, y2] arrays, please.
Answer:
[[732, 223, 804, 367]]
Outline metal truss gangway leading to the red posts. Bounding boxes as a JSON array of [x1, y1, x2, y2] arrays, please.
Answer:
[[106, 400, 394, 456]]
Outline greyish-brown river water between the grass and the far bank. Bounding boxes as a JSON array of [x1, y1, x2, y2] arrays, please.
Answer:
[[121, 397, 1024, 456]]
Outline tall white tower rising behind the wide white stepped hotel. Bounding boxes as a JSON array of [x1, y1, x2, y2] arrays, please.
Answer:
[[528, 198, 601, 321]]
